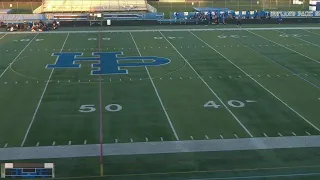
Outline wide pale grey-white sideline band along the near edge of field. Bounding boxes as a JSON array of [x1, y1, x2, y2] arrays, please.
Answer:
[[0, 136, 320, 161]]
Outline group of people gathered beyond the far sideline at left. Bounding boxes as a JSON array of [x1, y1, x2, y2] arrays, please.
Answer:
[[6, 20, 59, 32]]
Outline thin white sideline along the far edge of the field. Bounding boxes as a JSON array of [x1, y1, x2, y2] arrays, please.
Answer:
[[0, 26, 320, 34]]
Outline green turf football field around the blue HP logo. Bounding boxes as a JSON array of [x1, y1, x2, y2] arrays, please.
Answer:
[[0, 28, 320, 179]]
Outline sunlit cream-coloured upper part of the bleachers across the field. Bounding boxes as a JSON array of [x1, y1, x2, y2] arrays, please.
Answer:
[[33, 0, 148, 14]]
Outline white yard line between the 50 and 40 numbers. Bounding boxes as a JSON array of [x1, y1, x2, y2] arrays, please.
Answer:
[[129, 32, 179, 140]]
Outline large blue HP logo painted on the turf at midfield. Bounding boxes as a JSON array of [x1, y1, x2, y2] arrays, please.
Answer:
[[46, 52, 170, 75]]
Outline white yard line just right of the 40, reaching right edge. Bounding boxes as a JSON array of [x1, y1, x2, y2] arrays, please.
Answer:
[[190, 32, 320, 132]]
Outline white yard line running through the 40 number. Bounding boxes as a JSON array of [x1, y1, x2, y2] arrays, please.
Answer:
[[159, 31, 253, 137]]
